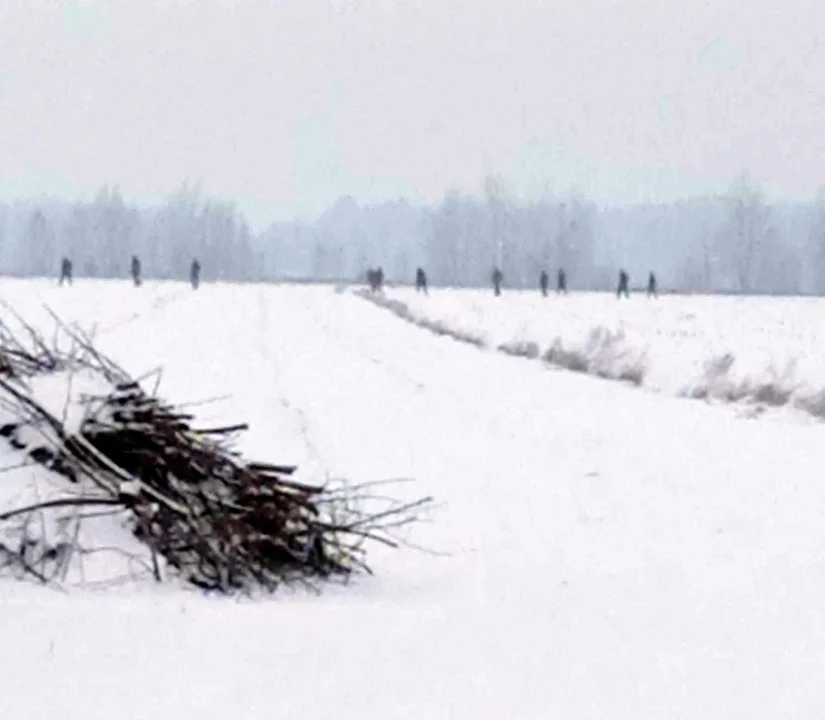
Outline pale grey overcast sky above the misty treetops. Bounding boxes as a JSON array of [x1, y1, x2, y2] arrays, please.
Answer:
[[0, 0, 825, 226]]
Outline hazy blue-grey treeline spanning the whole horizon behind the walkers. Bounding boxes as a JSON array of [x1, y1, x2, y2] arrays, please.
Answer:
[[0, 176, 825, 294]]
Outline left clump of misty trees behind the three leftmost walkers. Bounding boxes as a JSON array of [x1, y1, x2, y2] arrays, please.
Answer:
[[0, 185, 261, 280]]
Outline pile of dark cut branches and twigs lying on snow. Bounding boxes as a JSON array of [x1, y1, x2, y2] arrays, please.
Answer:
[[0, 306, 430, 593]]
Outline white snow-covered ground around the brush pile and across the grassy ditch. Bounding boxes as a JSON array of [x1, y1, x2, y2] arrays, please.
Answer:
[[0, 280, 825, 720]]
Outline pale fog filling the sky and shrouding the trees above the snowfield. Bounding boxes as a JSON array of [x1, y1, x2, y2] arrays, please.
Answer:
[[0, 0, 825, 292]]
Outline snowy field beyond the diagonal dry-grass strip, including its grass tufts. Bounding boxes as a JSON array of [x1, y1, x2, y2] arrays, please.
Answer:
[[374, 288, 825, 417]]
